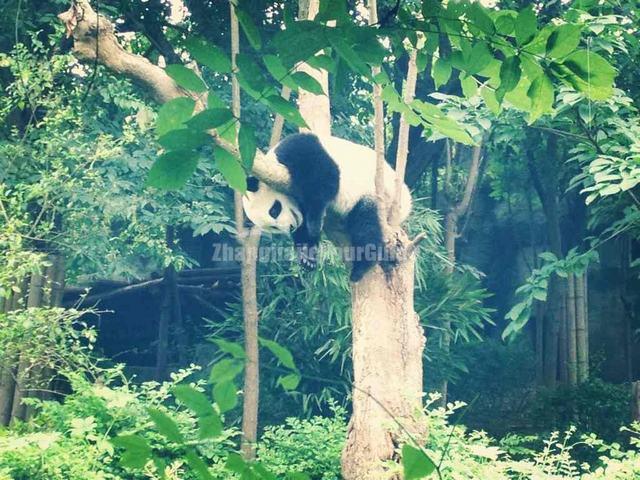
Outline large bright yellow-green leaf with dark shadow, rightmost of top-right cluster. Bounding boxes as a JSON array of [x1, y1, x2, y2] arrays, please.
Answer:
[[562, 50, 617, 100]]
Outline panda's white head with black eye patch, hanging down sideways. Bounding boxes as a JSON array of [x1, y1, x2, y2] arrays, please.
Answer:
[[242, 177, 302, 233]]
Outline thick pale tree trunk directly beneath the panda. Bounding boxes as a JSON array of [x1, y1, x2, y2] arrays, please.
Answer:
[[342, 246, 426, 480]]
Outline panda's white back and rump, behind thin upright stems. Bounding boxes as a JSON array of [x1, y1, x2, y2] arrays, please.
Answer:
[[318, 136, 411, 220]]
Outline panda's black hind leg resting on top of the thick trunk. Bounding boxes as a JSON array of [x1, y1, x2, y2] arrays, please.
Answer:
[[346, 198, 384, 282]]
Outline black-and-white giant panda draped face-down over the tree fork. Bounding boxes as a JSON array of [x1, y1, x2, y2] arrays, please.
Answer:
[[243, 133, 411, 282]]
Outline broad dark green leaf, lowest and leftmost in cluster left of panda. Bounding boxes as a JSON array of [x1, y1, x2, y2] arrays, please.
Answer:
[[146, 150, 199, 190]]
